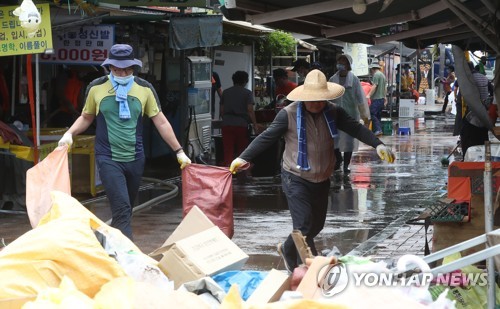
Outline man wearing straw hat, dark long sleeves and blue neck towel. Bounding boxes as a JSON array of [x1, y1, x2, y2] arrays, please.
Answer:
[[229, 70, 394, 272]]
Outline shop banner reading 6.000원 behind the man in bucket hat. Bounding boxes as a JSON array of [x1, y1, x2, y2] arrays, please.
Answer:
[[40, 25, 115, 65]]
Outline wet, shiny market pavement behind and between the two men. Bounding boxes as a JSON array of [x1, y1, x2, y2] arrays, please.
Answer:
[[0, 105, 457, 270]]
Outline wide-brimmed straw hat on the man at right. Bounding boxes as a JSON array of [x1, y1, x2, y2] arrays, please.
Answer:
[[286, 70, 345, 101]]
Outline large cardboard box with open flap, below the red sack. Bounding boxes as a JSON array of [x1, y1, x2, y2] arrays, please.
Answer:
[[150, 206, 248, 289]]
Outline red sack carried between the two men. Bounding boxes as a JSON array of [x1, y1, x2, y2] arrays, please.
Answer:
[[182, 164, 234, 238]]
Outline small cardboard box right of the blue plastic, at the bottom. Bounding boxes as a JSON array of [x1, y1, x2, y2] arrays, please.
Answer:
[[247, 268, 291, 305]]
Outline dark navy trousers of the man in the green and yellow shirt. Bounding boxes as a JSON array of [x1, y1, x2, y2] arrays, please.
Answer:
[[96, 158, 145, 239]]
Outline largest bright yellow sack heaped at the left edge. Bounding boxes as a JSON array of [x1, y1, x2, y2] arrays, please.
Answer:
[[0, 192, 126, 300]]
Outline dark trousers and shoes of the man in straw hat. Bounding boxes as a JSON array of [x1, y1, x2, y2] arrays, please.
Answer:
[[281, 170, 330, 268]]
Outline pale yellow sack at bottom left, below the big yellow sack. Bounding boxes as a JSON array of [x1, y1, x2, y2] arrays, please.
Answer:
[[23, 277, 94, 309]]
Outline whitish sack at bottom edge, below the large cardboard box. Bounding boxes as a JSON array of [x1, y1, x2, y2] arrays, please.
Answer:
[[94, 277, 210, 309]]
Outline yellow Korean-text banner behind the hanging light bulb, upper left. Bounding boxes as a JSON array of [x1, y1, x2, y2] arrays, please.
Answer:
[[0, 3, 52, 56]]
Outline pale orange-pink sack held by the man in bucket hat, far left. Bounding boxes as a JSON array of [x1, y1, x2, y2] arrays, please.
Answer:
[[26, 146, 71, 227]]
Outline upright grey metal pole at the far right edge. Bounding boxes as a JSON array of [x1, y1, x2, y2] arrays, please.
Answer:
[[483, 141, 496, 309]]
